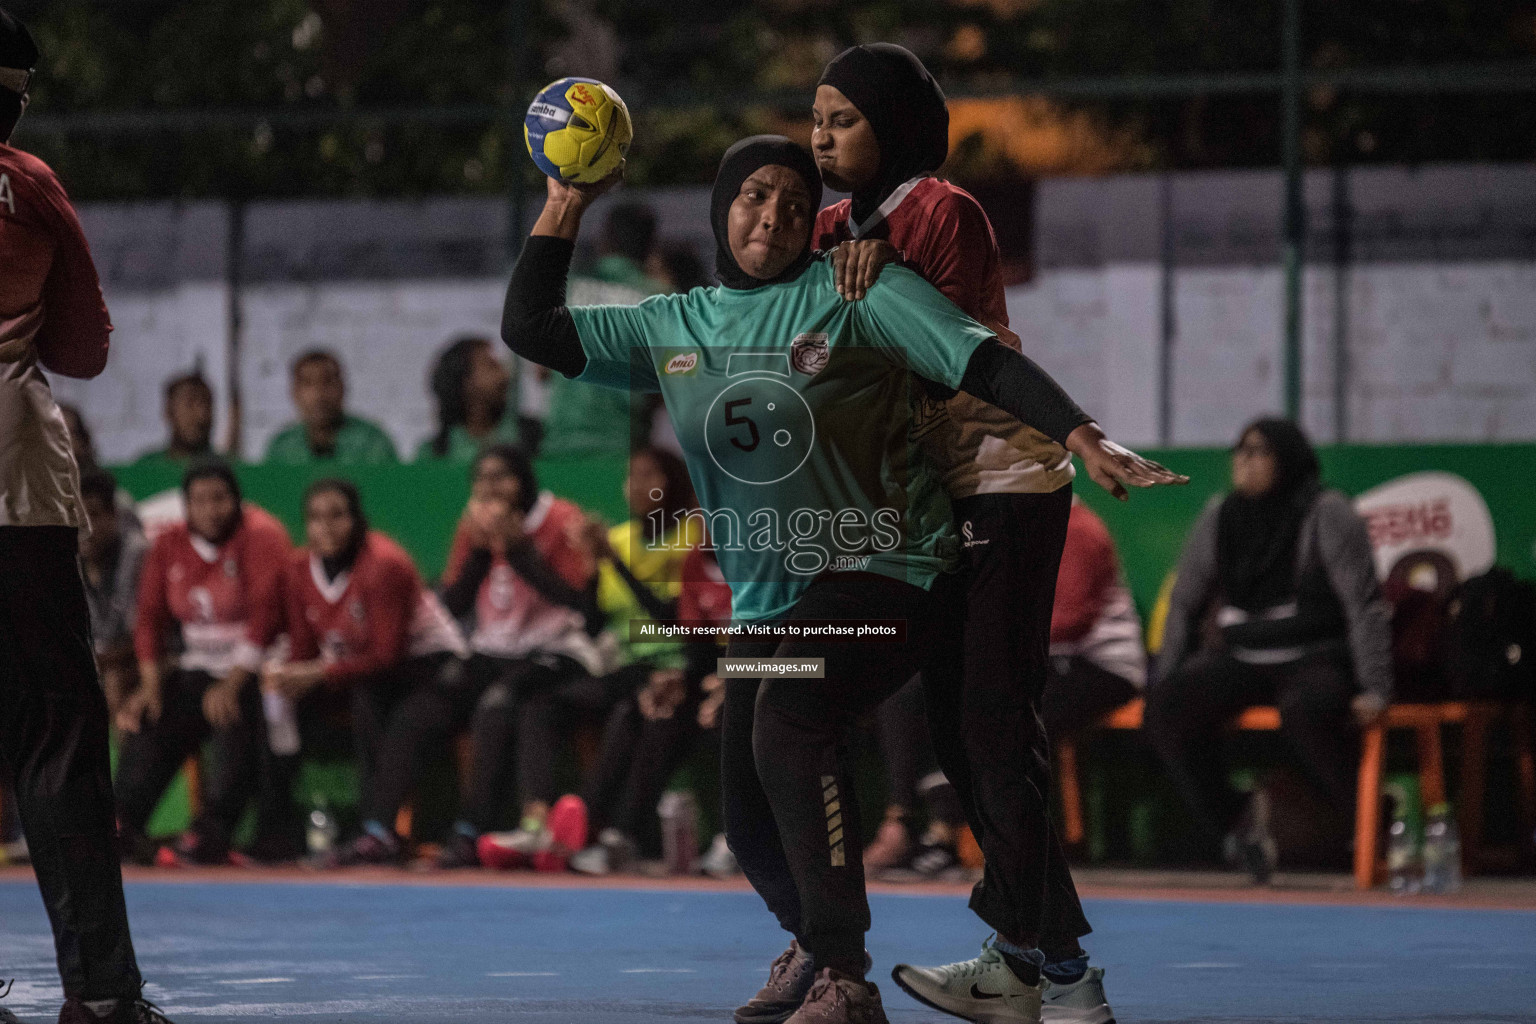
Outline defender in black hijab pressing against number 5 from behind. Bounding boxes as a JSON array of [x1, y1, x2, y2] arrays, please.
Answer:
[[804, 43, 1181, 1021]]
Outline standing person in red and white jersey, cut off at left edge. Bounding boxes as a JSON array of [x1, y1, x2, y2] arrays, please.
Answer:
[[0, 11, 169, 1024]]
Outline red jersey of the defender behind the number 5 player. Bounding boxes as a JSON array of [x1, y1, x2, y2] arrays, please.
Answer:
[[813, 177, 1072, 497]]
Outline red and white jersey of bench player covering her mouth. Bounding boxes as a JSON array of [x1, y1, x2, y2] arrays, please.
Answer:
[[444, 491, 604, 672]]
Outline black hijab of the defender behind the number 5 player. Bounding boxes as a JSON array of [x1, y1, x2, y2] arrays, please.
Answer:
[[816, 43, 949, 224]]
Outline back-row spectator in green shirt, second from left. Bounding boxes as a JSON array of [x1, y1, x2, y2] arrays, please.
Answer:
[[267, 348, 399, 465]]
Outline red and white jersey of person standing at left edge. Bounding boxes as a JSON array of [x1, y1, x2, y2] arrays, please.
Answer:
[[0, 144, 112, 527]]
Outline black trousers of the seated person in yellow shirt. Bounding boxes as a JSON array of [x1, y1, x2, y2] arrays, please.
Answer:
[[582, 666, 703, 854]]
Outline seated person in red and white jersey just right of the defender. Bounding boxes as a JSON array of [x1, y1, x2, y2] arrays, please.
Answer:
[[1040, 499, 1147, 737]]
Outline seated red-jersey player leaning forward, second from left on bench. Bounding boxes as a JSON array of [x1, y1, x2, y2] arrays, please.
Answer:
[[270, 479, 468, 866]]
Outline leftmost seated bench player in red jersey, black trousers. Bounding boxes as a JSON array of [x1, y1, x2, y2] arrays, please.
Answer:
[[117, 461, 290, 866]]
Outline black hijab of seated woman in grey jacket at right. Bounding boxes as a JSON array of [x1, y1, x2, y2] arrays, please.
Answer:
[[1217, 419, 1322, 611]]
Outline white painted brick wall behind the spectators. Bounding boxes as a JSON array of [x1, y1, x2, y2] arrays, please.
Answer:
[[66, 166, 1536, 461]]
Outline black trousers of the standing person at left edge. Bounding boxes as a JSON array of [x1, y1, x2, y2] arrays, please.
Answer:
[[0, 527, 140, 999]]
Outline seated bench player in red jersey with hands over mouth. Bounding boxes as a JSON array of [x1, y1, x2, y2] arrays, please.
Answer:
[[365, 445, 608, 867]]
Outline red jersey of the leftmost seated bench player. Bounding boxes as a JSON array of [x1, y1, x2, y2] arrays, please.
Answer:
[[134, 507, 292, 676]]
